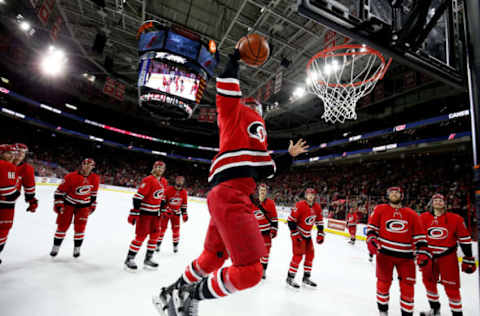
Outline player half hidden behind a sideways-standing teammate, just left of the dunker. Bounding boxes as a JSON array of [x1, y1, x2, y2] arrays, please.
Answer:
[[157, 176, 188, 253]]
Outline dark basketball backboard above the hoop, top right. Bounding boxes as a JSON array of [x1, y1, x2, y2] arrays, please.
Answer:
[[297, 0, 466, 89]]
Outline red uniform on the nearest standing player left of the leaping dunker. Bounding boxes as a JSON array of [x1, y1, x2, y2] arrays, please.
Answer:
[[158, 186, 187, 243]]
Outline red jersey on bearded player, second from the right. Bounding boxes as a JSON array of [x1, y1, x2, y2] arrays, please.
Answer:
[[367, 204, 427, 258]]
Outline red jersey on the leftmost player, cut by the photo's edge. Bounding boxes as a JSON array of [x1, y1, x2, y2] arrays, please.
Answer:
[[0, 160, 20, 209]]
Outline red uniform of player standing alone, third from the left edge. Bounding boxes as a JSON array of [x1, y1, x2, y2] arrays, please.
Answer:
[[55, 171, 100, 244]]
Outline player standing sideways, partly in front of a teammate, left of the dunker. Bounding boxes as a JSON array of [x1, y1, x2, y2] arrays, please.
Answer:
[[125, 161, 165, 271]]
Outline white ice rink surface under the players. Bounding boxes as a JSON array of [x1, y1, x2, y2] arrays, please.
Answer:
[[0, 186, 480, 316]]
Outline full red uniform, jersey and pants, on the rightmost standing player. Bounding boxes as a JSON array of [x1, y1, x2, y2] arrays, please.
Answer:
[[421, 212, 472, 312]]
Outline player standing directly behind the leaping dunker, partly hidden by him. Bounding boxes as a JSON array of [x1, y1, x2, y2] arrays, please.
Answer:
[[251, 183, 278, 279]]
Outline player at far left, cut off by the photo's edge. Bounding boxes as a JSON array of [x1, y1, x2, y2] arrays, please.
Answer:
[[0, 144, 20, 263]]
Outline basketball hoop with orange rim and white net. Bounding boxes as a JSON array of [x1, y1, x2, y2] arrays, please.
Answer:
[[307, 44, 392, 123]]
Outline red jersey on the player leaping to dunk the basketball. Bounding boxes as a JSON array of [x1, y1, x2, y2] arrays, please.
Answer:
[[208, 78, 276, 185]]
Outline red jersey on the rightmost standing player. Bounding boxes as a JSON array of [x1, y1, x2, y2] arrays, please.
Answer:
[[421, 212, 472, 256]]
